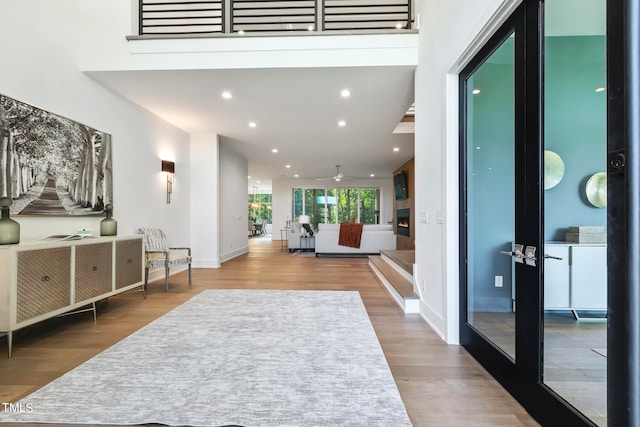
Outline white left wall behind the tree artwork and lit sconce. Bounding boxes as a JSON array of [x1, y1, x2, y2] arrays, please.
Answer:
[[0, 0, 191, 245]]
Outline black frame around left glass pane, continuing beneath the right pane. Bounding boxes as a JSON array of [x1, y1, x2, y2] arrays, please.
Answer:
[[459, 0, 608, 426]]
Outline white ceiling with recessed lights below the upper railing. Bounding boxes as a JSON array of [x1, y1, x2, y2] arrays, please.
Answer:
[[89, 66, 415, 188]]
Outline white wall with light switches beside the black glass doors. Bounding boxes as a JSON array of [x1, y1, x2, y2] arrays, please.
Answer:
[[415, 0, 518, 343]]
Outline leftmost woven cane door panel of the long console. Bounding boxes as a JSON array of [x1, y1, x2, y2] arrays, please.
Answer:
[[16, 247, 71, 323]]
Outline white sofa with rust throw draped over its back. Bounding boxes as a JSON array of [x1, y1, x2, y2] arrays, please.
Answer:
[[315, 224, 396, 256]]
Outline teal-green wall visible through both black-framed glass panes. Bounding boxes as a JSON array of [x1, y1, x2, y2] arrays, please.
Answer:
[[467, 36, 606, 311]]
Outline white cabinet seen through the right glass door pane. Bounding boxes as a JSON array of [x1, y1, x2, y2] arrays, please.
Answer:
[[544, 242, 607, 314]]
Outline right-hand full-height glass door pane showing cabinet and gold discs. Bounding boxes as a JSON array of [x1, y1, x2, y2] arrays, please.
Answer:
[[543, 0, 607, 426]]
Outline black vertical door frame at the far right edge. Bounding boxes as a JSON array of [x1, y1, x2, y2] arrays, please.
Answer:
[[607, 0, 640, 426]]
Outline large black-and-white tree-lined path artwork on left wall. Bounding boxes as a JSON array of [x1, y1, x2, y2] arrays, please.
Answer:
[[0, 95, 113, 216]]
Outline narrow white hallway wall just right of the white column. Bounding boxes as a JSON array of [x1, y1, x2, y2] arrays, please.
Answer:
[[219, 142, 249, 262]]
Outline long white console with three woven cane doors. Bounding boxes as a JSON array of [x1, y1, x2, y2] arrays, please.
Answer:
[[0, 236, 144, 357]]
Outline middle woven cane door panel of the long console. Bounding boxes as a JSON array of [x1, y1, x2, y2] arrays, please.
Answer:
[[74, 242, 113, 302]]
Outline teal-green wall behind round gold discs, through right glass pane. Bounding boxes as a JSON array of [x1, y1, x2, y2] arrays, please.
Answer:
[[544, 36, 607, 241]]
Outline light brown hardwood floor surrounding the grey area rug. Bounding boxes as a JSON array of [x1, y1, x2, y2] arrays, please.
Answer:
[[0, 238, 538, 427]]
